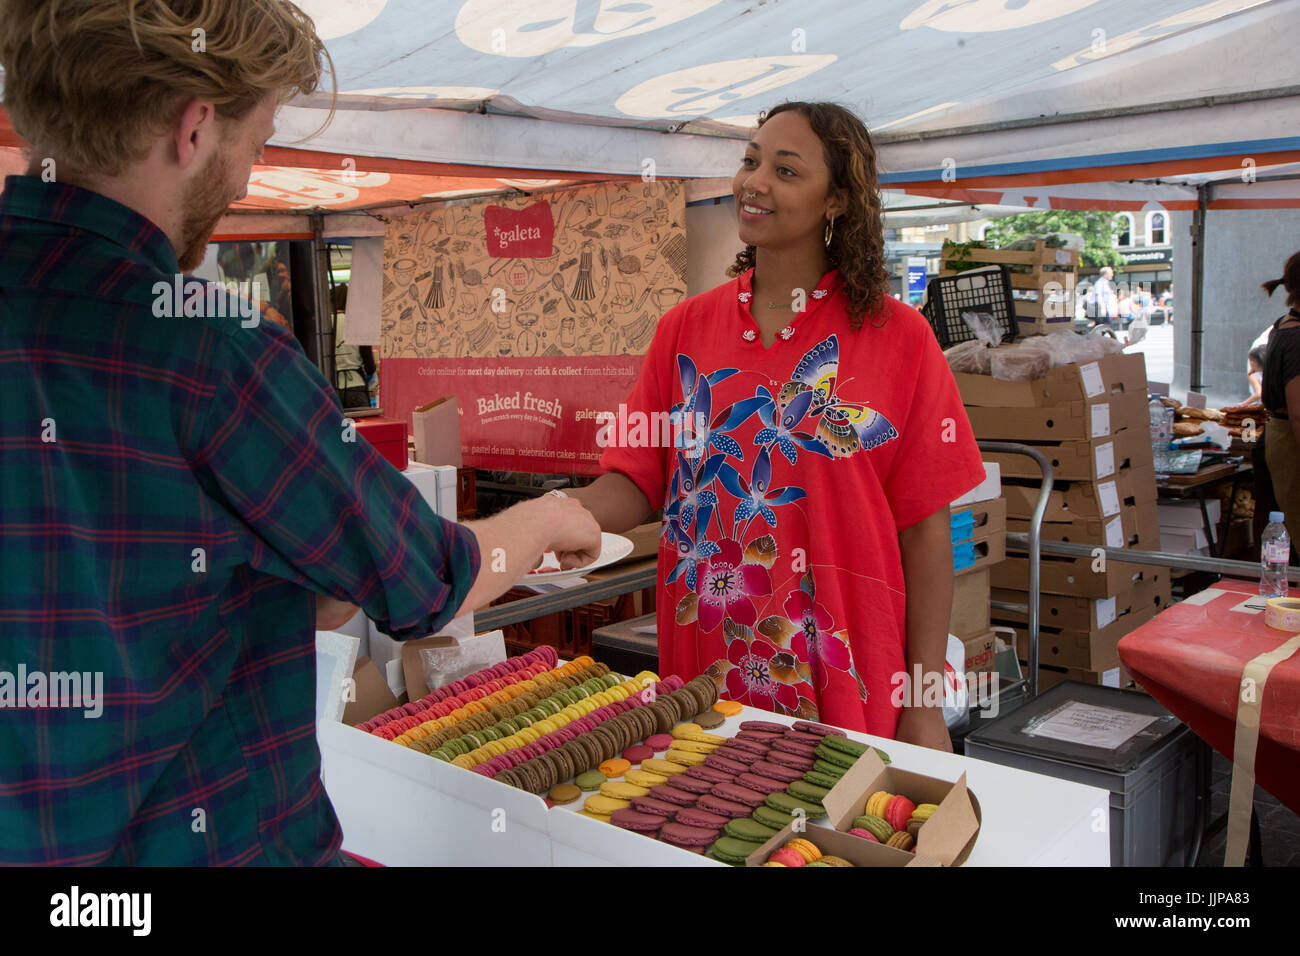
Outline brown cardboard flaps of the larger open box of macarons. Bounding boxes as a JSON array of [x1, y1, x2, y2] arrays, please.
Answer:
[[822, 750, 980, 866]]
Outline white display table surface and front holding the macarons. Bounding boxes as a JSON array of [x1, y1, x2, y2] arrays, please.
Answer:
[[317, 708, 1110, 866]]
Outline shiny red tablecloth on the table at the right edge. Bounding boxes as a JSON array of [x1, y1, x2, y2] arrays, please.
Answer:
[[1119, 579, 1300, 813]]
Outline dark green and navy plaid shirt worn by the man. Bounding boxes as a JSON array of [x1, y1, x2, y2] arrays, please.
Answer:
[[0, 176, 478, 865]]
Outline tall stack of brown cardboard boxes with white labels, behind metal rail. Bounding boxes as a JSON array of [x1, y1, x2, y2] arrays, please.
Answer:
[[956, 354, 1170, 687]]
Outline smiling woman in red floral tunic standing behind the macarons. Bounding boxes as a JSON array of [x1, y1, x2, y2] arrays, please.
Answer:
[[572, 103, 984, 749]]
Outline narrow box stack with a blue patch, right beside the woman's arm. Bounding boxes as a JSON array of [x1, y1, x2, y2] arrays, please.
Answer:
[[948, 463, 1006, 674]]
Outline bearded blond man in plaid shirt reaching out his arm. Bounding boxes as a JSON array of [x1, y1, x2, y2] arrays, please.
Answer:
[[0, 0, 599, 865]]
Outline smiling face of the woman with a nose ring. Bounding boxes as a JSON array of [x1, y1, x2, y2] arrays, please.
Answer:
[[732, 109, 844, 248]]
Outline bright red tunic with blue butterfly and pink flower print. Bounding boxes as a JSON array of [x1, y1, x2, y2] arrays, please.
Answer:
[[601, 272, 984, 737]]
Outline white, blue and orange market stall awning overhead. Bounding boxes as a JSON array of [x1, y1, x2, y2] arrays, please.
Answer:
[[0, 0, 1300, 209]]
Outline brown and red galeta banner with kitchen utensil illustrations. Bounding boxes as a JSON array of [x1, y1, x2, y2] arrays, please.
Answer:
[[380, 181, 686, 473]]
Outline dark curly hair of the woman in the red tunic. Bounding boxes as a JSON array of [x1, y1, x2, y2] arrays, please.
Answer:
[[727, 101, 889, 330]]
